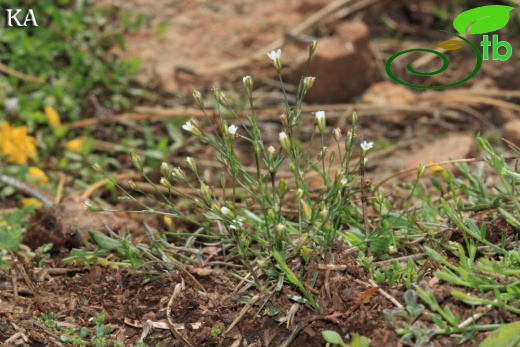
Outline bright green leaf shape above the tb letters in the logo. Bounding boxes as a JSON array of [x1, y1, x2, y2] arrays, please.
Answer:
[[453, 5, 515, 35]]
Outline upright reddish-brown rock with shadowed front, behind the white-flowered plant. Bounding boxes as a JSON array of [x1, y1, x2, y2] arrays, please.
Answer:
[[289, 21, 375, 104]]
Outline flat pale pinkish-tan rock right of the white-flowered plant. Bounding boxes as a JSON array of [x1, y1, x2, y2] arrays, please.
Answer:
[[401, 133, 475, 177]]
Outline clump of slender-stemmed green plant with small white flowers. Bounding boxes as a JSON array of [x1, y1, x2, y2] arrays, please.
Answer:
[[87, 41, 373, 311]]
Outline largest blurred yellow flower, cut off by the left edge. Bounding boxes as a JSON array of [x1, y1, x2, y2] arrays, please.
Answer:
[[0, 122, 37, 165]]
